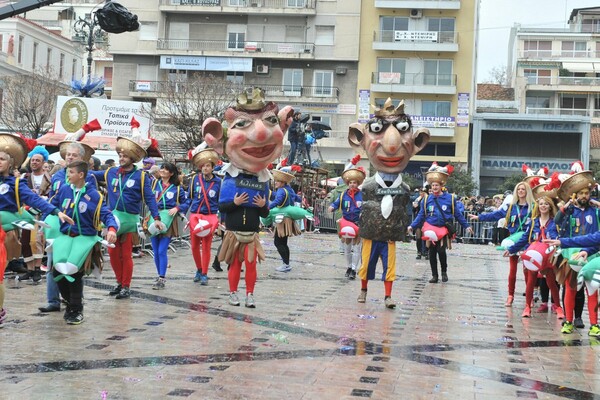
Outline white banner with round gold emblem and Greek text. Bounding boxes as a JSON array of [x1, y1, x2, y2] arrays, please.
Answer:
[[54, 96, 151, 138]]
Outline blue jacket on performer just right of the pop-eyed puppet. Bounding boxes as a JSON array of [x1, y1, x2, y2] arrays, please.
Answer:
[[410, 192, 469, 229]]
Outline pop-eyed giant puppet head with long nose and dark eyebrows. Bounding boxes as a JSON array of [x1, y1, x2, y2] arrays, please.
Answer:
[[348, 98, 430, 174]]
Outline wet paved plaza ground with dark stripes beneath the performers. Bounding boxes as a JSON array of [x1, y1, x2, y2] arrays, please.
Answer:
[[0, 234, 600, 400]]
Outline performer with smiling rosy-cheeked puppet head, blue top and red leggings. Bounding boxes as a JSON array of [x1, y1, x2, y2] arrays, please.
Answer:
[[202, 88, 293, 308]]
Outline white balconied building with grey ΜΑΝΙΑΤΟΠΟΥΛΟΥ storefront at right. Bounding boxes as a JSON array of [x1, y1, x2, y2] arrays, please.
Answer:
[[472, 7, 600, 194]]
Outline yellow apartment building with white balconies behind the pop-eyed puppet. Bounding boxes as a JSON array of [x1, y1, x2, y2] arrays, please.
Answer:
[[356, 0, 478, 179]]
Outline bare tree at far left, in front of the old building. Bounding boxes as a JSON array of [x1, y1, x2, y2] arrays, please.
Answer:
[[0, 68, 68, 139]]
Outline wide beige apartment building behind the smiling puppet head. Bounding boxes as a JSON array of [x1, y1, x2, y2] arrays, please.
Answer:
[[110, 0, 361, 165]]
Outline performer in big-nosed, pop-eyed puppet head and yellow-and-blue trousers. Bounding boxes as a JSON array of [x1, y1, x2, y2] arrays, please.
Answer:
[[348, 98, 430, 308]]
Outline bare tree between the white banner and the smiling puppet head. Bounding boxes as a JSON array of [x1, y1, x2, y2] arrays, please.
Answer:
[[153, 75, 242, 149]]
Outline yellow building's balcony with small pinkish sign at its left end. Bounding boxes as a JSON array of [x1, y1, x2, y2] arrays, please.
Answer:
[[371, 72, 456, 94]]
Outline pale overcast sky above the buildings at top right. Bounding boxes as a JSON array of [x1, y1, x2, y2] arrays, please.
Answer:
[[477, 0, 600, 82]]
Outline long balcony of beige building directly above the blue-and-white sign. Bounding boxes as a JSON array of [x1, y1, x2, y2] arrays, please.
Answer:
[[156, 38, 315, 59]]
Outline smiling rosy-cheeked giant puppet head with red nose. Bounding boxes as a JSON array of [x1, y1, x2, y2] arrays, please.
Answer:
[[202, 88, 294, 173]]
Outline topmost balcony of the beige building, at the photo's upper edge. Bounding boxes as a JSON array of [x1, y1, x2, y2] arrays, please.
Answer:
[[159, 0, 317, 15]]
